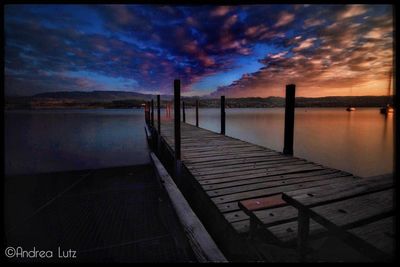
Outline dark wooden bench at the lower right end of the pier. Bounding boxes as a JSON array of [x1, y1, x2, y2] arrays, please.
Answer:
[[276, 175, 394, 261]]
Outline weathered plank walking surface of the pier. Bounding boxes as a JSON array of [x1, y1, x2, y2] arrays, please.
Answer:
[[155, 122, 370, 260]]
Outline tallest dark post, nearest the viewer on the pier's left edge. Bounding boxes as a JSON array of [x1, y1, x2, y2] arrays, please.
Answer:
[[174, 80, 181, 180]]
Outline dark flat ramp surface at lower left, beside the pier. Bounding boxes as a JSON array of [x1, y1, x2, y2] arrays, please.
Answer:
[[4, 165, 196, 262]]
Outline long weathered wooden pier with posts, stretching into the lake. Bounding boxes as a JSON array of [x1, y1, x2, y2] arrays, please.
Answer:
[[148, 82, 394, 261]]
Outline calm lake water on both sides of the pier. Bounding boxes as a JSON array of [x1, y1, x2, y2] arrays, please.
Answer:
[[5, 108, 393, 176]]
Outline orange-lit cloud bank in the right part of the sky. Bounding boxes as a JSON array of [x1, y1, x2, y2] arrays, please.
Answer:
[[212, 6, 393, 97]]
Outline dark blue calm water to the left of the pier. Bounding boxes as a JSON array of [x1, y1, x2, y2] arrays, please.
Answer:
[[5, 109, 150, 174]]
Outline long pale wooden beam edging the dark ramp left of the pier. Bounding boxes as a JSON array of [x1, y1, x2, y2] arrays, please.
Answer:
[[150, 152, 227, 262]]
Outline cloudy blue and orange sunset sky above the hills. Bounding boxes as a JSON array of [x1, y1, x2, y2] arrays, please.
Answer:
[[4, 4, 393, 98]]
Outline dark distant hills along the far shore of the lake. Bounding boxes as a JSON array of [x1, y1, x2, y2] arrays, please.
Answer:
[[5, 91, 393, 109]]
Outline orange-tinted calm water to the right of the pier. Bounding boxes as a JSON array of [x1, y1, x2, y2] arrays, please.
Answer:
[[186, 108, 393, 176]]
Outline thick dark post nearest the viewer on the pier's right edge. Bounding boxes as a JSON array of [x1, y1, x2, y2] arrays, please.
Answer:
[[283, 84, 296, 155]]
